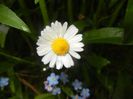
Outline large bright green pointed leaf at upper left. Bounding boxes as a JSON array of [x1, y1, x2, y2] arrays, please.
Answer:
[[0, 4, 30, 33]]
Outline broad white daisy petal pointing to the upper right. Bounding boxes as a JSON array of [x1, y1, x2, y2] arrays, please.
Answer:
[[64, 25, 78, 40]]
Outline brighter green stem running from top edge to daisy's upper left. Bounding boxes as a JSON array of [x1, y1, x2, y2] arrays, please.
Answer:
[[39, 0, 49, 25]]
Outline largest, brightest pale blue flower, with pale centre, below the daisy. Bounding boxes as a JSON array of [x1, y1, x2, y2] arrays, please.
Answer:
[[47, 73, 59, 86]]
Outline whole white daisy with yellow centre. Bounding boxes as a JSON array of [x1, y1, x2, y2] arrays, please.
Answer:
[[37, 21, 84, 69]]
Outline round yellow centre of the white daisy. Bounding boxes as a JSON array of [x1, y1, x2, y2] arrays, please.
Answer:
[[51, 38, 69, 55]]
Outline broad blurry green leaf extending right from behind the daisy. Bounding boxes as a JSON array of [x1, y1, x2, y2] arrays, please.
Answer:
[[83, 27, 124, 44]]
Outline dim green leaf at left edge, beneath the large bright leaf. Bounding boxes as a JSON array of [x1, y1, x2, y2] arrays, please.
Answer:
[[0, 25, 9, 48]]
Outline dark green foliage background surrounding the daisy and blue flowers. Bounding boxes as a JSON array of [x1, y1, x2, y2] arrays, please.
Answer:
[[0, 0, 133, 99]]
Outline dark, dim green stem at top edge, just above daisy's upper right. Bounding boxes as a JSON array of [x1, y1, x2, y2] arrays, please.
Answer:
[[67, 0, 73, 22]]
